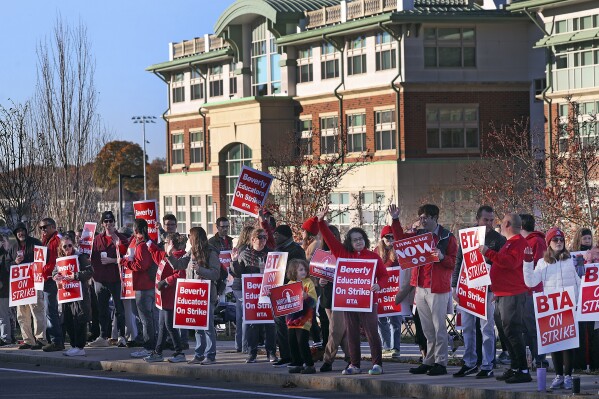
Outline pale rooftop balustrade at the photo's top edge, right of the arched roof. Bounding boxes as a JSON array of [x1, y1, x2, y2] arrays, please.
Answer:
[[306, 0, 397, 29]]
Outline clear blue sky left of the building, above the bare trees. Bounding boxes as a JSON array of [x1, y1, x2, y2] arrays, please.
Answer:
[[0, 0, 234, 160]]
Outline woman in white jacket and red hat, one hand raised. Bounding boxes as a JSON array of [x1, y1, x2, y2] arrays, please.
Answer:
[[524, 227, 580, 389]]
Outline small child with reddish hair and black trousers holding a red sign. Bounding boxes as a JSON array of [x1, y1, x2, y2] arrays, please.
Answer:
[[285, 259, 316, 374]]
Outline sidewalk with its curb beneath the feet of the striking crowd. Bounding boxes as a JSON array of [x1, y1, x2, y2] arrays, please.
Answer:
[[0, 341, 599, 399]]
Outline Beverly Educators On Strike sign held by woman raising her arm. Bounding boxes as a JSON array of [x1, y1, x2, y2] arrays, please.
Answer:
[[333, 258, 377, 312]]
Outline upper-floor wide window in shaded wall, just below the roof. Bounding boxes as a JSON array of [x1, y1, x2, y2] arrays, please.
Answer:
[[424, 28, 476, 68]]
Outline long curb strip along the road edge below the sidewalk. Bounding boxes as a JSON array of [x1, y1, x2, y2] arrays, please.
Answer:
[[0, 353, 580, 399]]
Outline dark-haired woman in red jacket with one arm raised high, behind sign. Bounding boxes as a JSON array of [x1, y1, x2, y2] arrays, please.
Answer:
[[317, 207, 387, 375]]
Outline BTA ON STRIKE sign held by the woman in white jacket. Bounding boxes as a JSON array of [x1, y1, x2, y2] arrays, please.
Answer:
[[533, 287, 579, 355]]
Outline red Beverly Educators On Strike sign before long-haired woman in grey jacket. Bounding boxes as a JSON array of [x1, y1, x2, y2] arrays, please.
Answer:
[[173, 279, 212, 330]]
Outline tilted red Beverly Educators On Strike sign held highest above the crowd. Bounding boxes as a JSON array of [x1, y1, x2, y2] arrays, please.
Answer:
[[231, 166, 273, 217]]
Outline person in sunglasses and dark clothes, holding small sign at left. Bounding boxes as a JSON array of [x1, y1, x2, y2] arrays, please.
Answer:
[[52, 235, 94, 356]]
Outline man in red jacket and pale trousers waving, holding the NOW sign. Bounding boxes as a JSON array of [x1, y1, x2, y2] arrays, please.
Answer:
[[389, 204, 458, 376]]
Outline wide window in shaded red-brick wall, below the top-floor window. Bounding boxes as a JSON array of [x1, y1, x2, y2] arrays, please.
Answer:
[[426, 104, 479, 150]]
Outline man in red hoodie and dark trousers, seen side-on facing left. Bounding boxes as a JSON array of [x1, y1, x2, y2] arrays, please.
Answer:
[[480, 213, 532, 384]]
